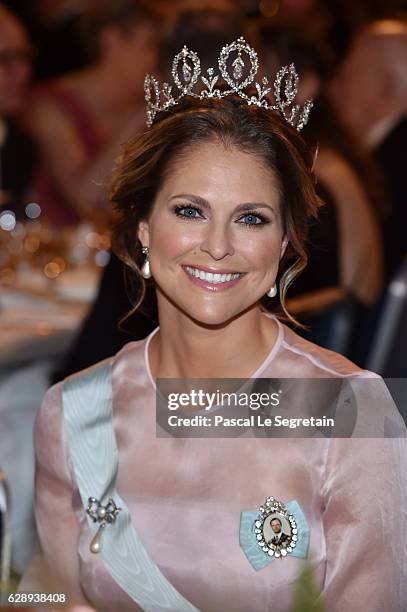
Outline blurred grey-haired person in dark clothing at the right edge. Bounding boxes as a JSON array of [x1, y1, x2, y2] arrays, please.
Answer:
[[332, 20, 407, 281]]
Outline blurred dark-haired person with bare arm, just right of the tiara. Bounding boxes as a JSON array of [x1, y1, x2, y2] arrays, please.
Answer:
[[260, 26, 382, 345]]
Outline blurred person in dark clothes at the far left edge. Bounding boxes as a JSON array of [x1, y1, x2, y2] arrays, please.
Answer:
[[0, 5, 35, 214]]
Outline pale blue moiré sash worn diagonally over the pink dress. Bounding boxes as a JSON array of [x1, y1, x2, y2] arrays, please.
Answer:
[[63, 361, 199, 612]]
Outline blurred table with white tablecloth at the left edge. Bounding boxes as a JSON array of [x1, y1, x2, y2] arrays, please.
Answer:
[[0, 270, 98, 573]]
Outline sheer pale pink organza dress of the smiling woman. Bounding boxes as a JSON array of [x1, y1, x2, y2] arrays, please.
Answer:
[[20, 322, 407, 612]]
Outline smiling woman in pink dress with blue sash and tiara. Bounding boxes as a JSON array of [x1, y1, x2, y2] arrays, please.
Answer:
[[19, 39, 407, 612]]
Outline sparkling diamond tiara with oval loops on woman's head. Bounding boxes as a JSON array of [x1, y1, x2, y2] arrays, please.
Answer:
[[144, 37, 313, 131]]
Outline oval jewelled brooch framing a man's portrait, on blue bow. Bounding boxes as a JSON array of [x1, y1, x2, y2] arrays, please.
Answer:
[[254, 497, 298, 559]]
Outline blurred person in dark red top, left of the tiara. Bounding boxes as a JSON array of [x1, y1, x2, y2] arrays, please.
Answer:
[[26, 0, 161, 225]]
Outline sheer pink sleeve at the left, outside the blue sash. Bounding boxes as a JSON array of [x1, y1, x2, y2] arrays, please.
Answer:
[[19, 383, 92, 610]]
